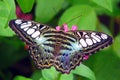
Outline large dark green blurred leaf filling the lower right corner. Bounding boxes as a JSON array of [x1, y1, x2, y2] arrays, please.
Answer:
[[87, 47, 120, 80]]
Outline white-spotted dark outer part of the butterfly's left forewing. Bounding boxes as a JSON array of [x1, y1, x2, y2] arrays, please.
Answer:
[[9, 19, 48, 45]]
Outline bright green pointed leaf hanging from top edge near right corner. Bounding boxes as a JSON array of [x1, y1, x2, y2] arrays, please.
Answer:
[[92, 0, 113, 12]]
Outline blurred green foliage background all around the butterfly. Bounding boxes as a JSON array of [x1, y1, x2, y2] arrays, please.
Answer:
[[0, 0, 120, 80]]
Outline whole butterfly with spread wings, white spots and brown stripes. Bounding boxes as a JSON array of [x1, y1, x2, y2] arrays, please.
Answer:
[[9, 19, 112, 73]]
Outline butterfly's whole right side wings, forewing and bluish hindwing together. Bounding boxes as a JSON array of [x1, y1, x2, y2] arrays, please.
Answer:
[[54, 31, 112, 73]]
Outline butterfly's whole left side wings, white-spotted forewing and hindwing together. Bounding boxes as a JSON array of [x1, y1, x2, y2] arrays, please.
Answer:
[[9, 19, 54, 68]]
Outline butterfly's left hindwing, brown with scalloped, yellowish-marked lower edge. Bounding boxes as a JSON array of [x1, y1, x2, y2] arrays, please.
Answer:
[[29, 45, 54, 69]]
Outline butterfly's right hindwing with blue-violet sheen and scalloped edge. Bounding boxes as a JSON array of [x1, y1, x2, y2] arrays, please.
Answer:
[[54, 51, 83, 73]]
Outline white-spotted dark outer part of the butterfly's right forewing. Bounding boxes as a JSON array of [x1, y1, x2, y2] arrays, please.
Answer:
[[74, 30, 112, 55]]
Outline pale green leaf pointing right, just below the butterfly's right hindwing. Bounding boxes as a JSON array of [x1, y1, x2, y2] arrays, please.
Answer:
[[72, 64, 96, 80]]
